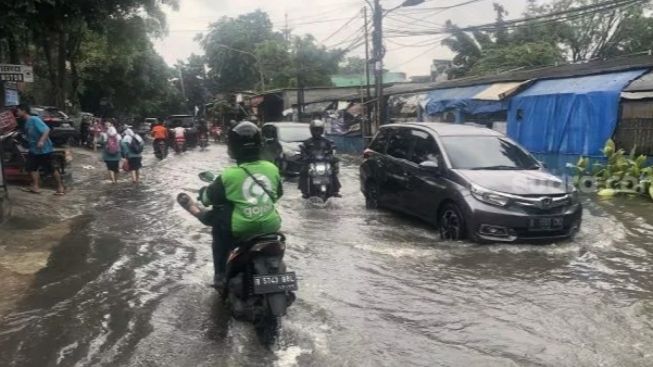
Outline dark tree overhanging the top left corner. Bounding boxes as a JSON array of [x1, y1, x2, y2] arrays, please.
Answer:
[[0, 0, 176, 107]]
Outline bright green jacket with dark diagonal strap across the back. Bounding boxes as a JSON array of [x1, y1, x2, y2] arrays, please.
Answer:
[[201, 161, 283, 240]]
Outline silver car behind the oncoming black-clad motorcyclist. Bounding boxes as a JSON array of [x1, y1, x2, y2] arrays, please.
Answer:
[[262, 122, 311, 176]]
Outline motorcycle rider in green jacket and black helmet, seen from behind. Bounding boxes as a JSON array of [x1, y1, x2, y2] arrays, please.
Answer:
[[177, 121, 283, 290]]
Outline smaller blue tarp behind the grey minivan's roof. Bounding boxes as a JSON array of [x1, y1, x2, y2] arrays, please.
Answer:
[[426, 84, 507, 115]]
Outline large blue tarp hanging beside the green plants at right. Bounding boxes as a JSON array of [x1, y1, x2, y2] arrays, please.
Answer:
[[508, 69, 647, 155]]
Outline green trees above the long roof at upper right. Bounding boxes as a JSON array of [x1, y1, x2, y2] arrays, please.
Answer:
[[442, 0, 653, 78]]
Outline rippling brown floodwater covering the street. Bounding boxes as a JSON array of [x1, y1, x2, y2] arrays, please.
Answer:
[[0, 145, 653, 367]]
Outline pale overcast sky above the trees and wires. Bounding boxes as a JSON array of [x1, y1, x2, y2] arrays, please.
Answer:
[[154, 0, 528, 75]]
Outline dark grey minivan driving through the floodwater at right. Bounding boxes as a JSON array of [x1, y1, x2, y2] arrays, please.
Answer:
[[360, 123, 582, 242]]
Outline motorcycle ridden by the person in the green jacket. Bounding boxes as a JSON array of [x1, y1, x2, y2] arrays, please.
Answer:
[[181, 172, 297, 346]]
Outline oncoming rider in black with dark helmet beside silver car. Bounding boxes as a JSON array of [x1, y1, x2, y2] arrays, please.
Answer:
[[299, 120, 341, 199]]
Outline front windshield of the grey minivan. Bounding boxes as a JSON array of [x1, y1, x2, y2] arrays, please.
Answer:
[[442, 136, 540, 170]]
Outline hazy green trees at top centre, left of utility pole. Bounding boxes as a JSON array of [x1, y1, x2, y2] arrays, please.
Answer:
[[199, 10, 343, 92]]
